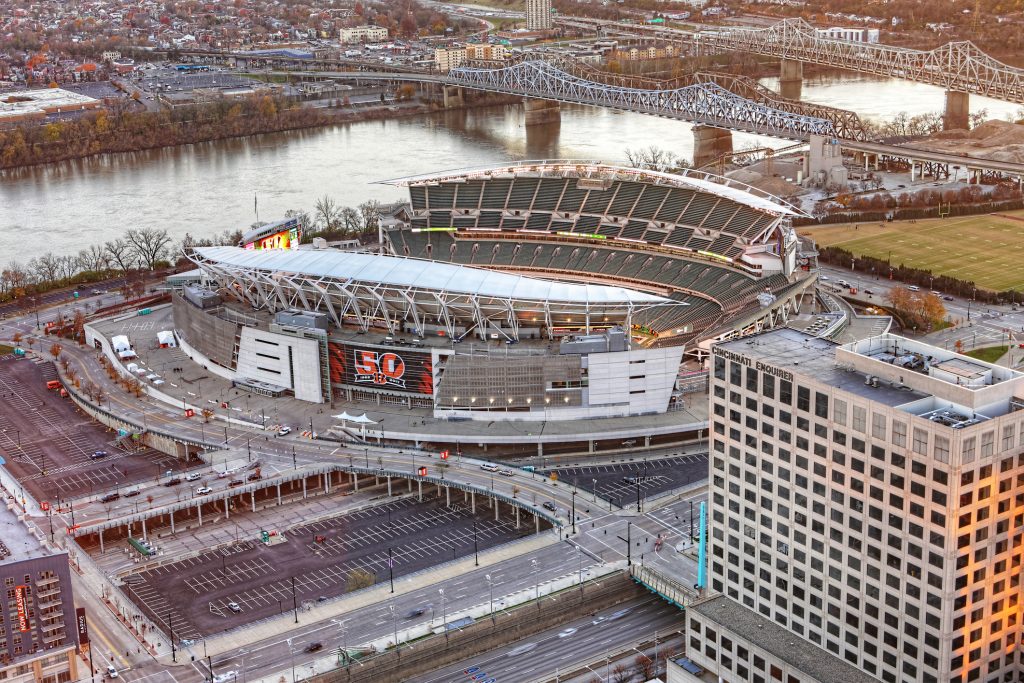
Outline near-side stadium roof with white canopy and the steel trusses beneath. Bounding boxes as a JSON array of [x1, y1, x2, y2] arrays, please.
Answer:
[[187, 247, 687, 340]]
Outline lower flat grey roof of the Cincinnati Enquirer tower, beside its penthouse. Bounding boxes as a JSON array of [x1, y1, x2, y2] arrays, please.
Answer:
[[716, 328, 927, 405]]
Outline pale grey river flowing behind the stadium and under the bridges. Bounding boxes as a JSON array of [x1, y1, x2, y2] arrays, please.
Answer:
[[0, 75, 1019, 263]]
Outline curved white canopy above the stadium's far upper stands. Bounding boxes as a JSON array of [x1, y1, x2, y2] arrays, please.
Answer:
[[380, 159, 805, 216]]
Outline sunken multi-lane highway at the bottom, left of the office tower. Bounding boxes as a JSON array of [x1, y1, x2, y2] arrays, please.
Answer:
[[407, 596, 686, 683]]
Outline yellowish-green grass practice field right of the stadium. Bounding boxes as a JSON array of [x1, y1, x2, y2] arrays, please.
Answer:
[[800, 211, 1024, 292]]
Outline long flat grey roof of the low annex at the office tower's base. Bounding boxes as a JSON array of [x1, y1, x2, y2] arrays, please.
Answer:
[[688, 595, 878, 683]]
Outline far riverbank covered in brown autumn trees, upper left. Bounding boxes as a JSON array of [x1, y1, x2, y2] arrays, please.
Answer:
[[0, 95, 520, 170]]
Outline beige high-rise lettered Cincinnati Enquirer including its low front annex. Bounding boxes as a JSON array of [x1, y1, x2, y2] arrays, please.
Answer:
[[687, 329, 1024, 683]]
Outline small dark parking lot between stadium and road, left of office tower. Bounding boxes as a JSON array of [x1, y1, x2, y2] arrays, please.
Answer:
[[546, 453, 708, 506]]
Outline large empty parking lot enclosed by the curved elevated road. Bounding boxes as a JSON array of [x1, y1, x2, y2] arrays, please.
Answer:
[[126, 498, 532, 638]]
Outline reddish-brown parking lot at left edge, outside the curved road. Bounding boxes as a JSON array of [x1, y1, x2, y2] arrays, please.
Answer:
[[0, 355, 195, 502]]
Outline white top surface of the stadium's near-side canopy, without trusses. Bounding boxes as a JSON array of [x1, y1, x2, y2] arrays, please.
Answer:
[[195, 247, 670, 304]]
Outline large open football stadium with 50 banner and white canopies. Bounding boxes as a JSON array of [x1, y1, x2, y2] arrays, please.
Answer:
[[173, 161, 811, 438]]
